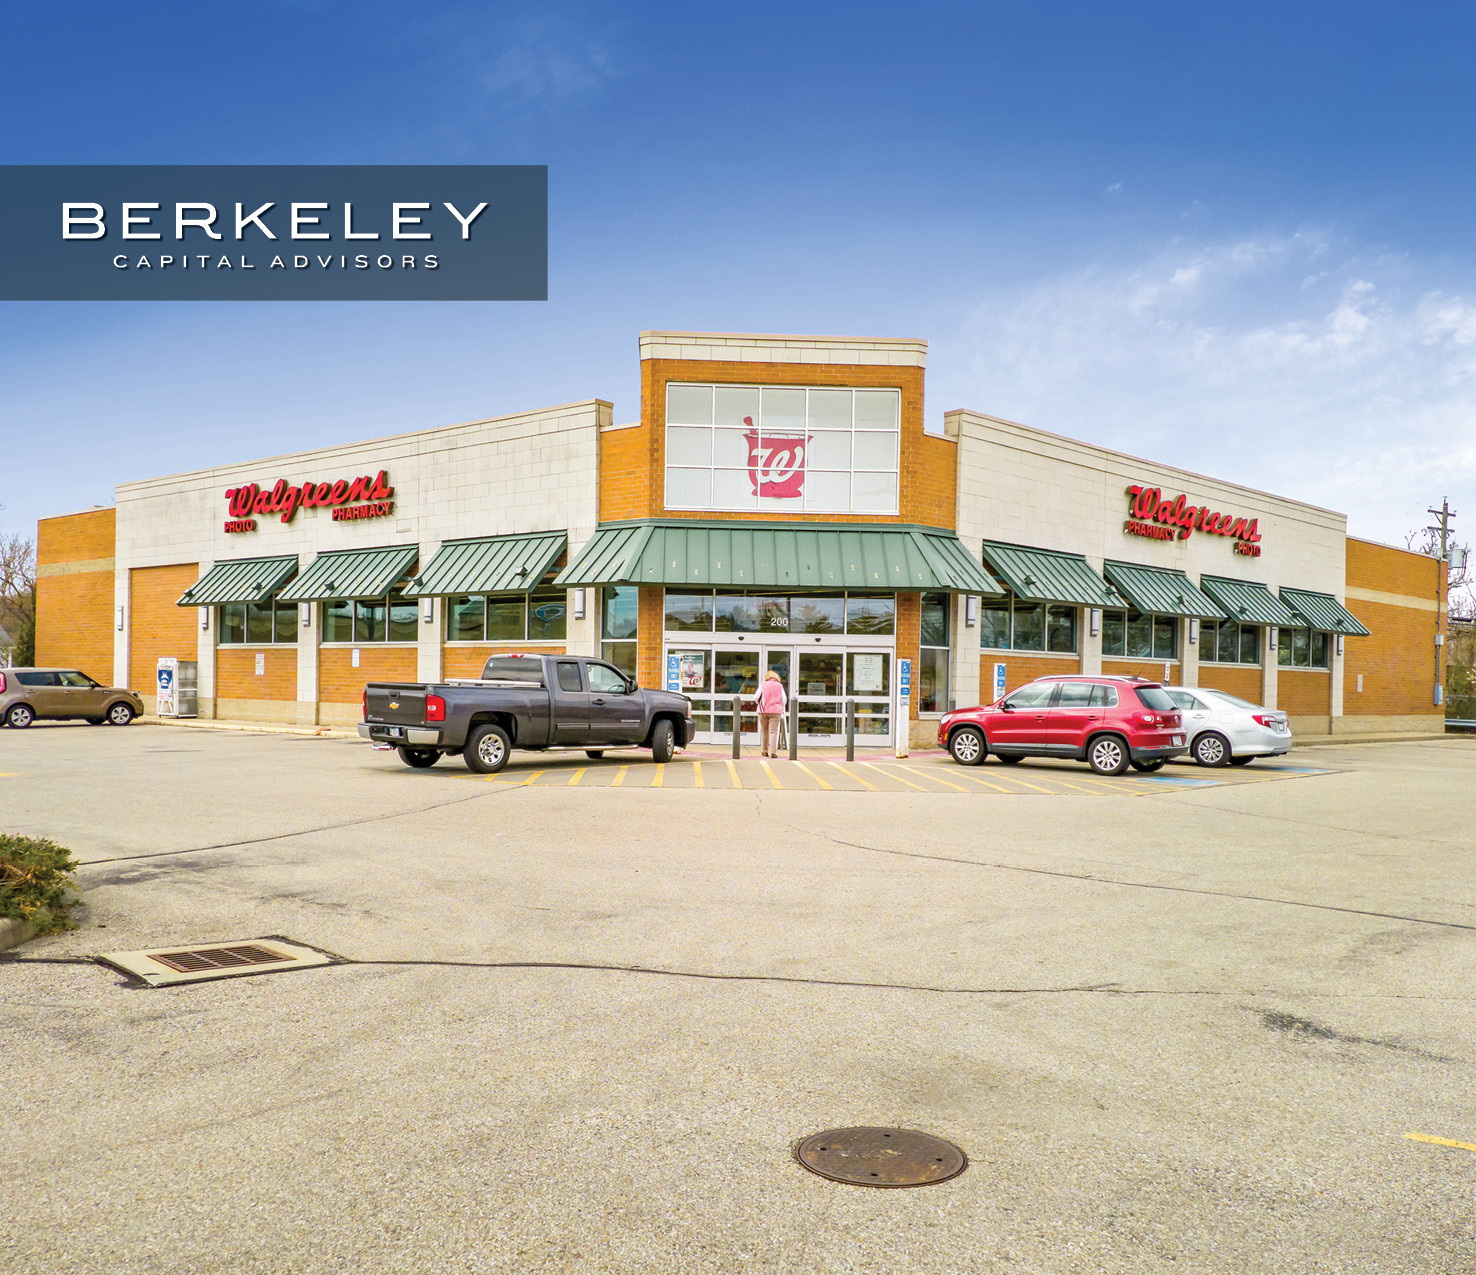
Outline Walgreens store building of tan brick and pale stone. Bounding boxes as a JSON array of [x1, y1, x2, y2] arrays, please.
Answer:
[[37, 332, 1445, 745]]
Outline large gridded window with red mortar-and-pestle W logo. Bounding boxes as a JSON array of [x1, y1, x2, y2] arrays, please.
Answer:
[[666, 384, 902, 515]]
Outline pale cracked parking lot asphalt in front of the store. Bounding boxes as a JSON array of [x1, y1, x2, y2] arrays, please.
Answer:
[[0, 725, 1476, 1275]]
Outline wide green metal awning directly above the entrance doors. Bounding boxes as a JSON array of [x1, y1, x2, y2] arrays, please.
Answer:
[[554, 519, 1001, 595]]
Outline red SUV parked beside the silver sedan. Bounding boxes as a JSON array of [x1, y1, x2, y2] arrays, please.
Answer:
[[937, 677, 1188, 775]]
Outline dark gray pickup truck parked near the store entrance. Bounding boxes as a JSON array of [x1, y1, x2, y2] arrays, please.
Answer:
[[359, 655, 692, 775]]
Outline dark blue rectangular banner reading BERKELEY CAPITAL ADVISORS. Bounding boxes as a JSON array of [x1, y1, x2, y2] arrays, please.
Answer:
[[0, 165, 548, 301]]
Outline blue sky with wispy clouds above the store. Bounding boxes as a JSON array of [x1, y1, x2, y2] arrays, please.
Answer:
[[0, 0, 1476, 542]]
